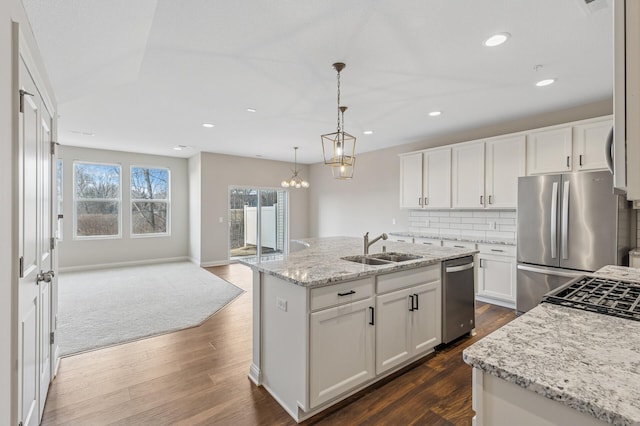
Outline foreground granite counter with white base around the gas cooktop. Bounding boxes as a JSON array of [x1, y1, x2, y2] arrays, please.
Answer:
[[463, 266, 640, 426]]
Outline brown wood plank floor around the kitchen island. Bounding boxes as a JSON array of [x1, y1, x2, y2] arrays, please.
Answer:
[[42, 264, 514, 426]]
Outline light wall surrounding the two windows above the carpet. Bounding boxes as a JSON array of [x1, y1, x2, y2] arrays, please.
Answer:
[[58, 146, 189, 271]]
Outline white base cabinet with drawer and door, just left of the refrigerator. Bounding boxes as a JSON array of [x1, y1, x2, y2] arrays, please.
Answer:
[[476, 244, 516, 308]]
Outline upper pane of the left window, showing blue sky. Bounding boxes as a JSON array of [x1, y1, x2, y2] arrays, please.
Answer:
[[75, 163, 120, 199]]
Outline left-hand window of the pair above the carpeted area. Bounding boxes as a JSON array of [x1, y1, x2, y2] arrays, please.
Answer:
[[73, 162, 121, 238]]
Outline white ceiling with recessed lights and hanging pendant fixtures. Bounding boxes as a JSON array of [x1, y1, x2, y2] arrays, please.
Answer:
[[23, 0, 613, 163]]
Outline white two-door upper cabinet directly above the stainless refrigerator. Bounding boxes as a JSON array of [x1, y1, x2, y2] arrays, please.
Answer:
[[527, 116, 613, 175]]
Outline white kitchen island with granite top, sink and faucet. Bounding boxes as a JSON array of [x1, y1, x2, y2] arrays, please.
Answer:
[[243, 237, 476, 421]]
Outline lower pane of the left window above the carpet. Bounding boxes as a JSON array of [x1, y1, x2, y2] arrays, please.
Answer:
[[76, 201, 119, 237]]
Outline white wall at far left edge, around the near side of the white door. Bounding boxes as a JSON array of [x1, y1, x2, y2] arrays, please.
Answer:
[[0, 0, 55, 425]]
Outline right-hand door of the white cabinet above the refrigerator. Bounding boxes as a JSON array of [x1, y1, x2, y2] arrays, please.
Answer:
[[573, 119, 613, 171]]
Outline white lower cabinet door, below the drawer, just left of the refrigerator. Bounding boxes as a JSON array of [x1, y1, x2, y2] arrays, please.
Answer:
[[478, 254, 516, 303]]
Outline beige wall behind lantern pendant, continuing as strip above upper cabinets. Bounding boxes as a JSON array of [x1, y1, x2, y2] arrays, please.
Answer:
[[309, 99, 613, 237]]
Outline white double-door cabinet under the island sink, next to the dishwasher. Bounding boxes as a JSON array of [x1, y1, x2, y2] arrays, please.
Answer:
[[376, 265, 442, 374]]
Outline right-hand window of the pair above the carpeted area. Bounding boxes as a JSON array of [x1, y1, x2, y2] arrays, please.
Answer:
[[131, 167, 170, 236]]
